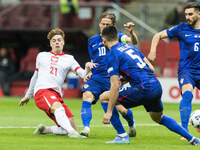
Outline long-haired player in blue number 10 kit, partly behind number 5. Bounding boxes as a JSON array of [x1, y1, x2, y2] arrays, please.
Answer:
[[80, 12, 138, 137]]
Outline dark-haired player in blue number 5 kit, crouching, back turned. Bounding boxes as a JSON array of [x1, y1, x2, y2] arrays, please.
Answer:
[[101, 26, 200, 145]]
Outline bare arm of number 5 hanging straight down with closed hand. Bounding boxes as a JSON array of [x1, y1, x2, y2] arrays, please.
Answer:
[[102, 75, 119, 124]]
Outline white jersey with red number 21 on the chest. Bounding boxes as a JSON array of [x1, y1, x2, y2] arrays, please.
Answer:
[[34, 52, 80, 96]]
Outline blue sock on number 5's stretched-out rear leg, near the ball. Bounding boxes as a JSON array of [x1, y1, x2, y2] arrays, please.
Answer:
[[159, 115, 193, 141]]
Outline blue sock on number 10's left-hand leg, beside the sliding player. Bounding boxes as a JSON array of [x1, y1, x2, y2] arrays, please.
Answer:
[[81, 101, 92, 127]]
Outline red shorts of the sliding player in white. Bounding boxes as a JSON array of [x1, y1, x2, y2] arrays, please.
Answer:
[[34, 89, 73, 126]]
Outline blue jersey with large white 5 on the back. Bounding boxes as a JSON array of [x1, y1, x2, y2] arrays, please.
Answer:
[[106, 43, 159, 91]]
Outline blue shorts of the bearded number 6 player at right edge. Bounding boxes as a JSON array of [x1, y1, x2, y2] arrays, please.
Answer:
[[178, 71, 200, 92]]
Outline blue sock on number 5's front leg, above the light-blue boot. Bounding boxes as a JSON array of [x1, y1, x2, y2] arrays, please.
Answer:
[[101, 102, 126, 134]]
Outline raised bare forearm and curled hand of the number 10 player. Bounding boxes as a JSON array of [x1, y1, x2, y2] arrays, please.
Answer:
[[124, 22, 138, 45]]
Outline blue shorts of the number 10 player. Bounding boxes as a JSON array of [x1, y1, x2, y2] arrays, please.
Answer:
[[82, 78, 110, 104]]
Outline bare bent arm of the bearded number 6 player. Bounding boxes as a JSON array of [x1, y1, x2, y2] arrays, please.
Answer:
[[147, 30, 168, 63]]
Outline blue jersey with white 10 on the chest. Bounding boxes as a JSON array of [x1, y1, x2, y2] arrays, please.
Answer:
[[88, 31, 127, 78]]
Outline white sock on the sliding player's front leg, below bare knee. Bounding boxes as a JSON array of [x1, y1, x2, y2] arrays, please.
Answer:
[[54, 107, 75, 133]]
